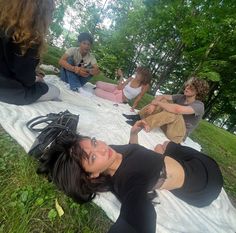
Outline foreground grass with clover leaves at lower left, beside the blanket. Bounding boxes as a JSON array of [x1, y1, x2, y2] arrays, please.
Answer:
[[0, 128, 111, 233]]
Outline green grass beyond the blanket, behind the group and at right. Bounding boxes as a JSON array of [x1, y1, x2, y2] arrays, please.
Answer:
[[39, 46, 236, 199]]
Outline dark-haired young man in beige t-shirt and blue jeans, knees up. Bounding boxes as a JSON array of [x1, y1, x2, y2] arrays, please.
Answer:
[[59, 32, 100, 95]]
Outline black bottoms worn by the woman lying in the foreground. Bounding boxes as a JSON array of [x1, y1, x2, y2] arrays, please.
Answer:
[[165, 142, 223, 207]]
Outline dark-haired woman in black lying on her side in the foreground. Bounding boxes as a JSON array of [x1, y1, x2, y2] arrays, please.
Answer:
[[38, 121, 223, 233]]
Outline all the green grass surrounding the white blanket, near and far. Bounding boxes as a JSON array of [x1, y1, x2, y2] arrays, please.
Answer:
[[0, 44, 236, 233]]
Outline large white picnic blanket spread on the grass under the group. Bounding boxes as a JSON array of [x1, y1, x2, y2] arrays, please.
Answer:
[[0, 75, 236, 233]]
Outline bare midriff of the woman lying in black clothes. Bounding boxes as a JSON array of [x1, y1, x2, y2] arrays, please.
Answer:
[[159, 156, 185, 190]]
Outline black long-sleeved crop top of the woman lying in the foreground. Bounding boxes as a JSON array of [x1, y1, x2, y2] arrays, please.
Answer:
[[109, 144, 164, 233]]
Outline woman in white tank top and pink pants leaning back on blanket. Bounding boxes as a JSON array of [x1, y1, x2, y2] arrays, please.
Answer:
[[95, 67, 151, 111]]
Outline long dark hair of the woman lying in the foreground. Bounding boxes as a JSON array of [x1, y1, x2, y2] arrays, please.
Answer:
[[37, 133, 111, 203]]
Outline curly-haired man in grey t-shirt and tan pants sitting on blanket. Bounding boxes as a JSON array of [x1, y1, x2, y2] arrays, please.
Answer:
[[123, 77, 209, 143]]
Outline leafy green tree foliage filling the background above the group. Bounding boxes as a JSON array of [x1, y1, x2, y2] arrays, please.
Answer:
[[47, 0, 236, 131]]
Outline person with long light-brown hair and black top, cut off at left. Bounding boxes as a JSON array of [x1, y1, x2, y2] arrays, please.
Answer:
[[0, 0, 60, 105]]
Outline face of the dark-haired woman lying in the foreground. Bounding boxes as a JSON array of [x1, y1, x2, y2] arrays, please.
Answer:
[[80, 138, 116, 178]]
